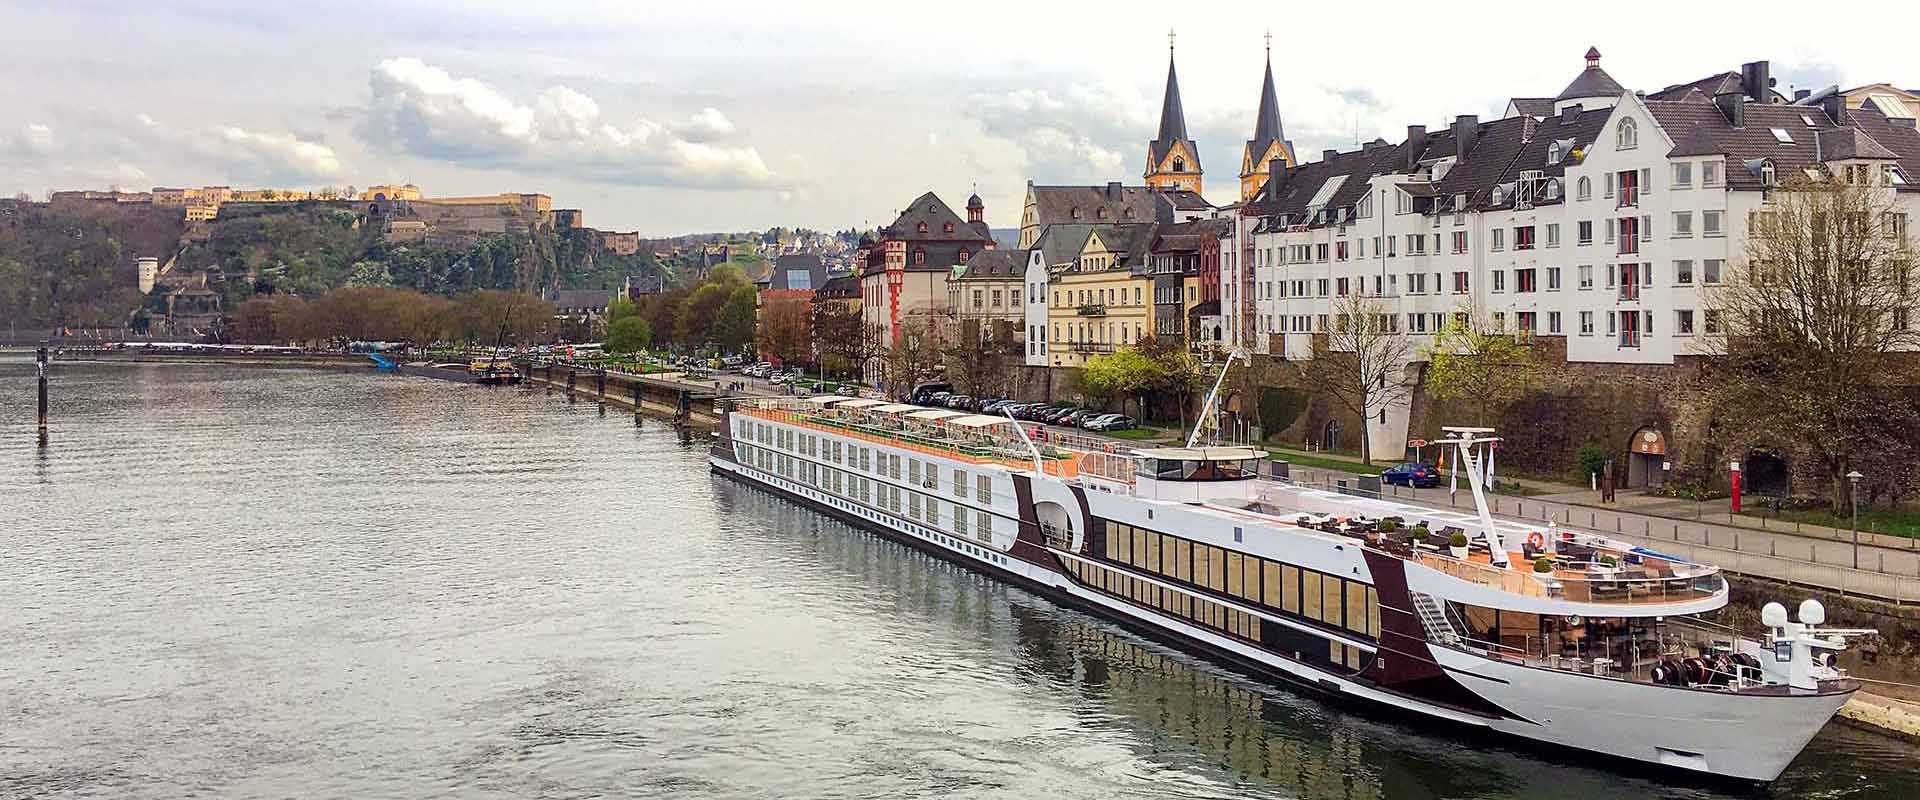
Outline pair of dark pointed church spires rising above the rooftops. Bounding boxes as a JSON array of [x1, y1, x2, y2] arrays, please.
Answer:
[[1146, 31, 1294, 201]]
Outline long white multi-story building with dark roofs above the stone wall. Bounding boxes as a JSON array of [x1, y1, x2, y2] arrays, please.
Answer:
[[1223, 50, 1920, 457]]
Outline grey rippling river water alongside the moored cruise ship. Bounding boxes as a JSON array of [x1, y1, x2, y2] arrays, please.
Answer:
[[0, 357, 1920, 800]]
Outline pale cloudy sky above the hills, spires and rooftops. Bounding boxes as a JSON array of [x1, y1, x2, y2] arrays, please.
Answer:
[[0, 0, 1920, 234]]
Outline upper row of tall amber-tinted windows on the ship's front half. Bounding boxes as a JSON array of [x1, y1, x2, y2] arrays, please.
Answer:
[[1094, 522, 1380, 639]]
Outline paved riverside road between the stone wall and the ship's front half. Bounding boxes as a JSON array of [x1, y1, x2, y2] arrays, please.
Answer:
[[1292, 464, 1920, 579]]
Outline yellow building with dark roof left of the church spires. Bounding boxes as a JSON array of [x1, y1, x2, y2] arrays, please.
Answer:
[[1046, 223, 1154, 366]]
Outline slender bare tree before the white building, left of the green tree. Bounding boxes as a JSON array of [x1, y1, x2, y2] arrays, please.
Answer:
[[1302, 294, 1415, 464]]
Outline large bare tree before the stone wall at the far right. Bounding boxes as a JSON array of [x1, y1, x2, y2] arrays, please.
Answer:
[[1701, 169, 1920, 514]]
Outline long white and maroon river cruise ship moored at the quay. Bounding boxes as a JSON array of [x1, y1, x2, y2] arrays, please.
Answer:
[[710, 395, 1860, 783]]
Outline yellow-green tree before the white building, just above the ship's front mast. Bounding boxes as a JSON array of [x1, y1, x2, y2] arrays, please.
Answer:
[[1421, 306, 1538, 426]]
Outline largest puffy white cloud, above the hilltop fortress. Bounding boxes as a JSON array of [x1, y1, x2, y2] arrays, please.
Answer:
[[357, 58, 776, 188]]
